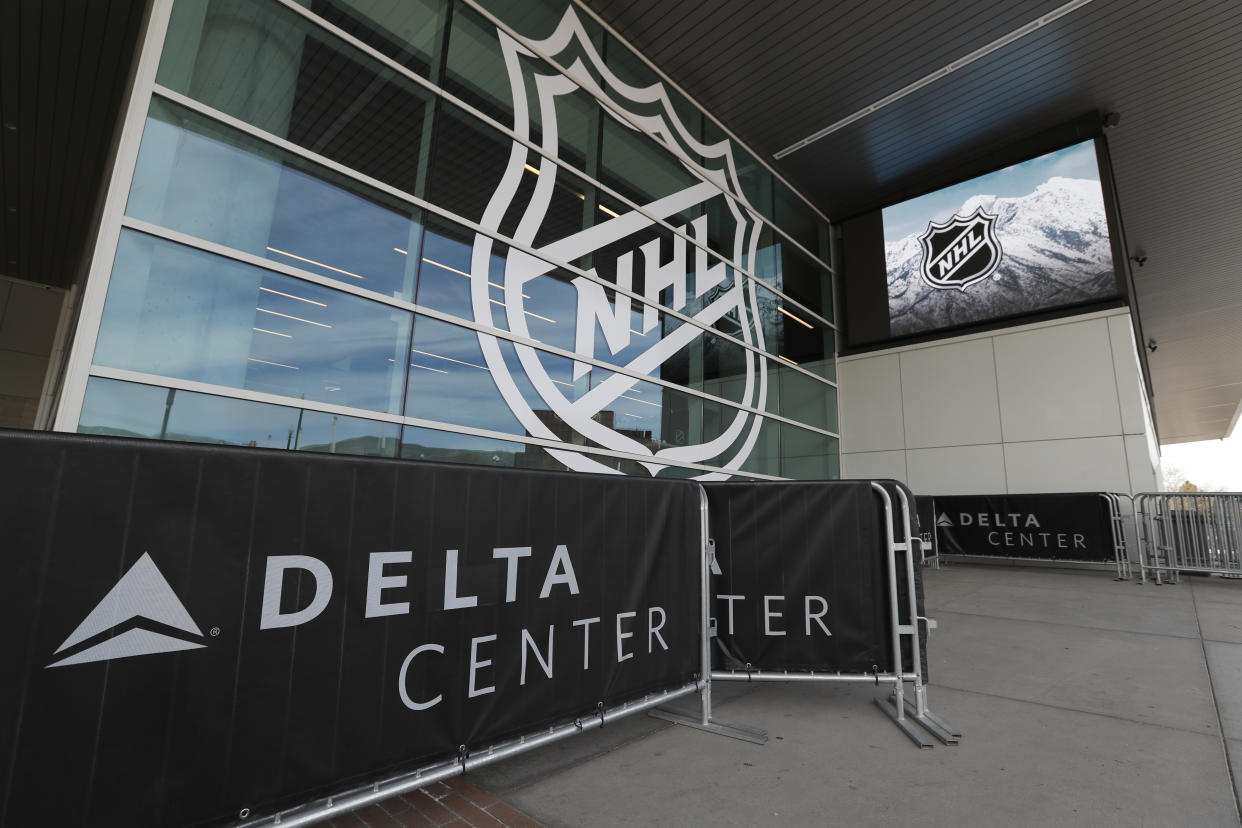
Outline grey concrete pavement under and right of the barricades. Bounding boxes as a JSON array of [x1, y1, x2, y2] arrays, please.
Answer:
[[468, 565, 1242, 827]]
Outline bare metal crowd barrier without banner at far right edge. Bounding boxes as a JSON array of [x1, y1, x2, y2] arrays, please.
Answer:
[[1134, 492, 1242, 583]]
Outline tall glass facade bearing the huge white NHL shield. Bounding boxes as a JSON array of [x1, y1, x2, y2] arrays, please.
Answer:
[[78, 0, 838, 479]]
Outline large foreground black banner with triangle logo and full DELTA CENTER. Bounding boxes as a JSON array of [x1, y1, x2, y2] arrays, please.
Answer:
[[0, 432, 700, 826]]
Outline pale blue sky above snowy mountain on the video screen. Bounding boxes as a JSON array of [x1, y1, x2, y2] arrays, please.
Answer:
[[883, 140, 1099, 243]]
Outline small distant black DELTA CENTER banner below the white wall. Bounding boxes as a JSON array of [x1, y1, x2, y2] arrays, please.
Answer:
[[934, 493, 1114, 562]]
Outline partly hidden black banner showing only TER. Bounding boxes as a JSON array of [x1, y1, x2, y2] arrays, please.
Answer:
[[705, 480, 893, 673]]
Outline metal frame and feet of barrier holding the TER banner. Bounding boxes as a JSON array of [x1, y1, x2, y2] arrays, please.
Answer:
[[700, 480, 961, 747]]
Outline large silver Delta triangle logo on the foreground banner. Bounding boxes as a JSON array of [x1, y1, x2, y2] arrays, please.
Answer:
[[47, 552, 205, 668]]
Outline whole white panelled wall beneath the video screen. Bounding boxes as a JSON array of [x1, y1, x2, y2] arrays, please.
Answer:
[[840, 310, 1160, 494]]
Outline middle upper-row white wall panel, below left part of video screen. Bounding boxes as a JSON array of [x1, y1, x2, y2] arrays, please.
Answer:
[[902, 339, 1001, 448]]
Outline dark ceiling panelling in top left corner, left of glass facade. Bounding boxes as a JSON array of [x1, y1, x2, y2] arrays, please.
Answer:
[[0, 0, 147, 288]]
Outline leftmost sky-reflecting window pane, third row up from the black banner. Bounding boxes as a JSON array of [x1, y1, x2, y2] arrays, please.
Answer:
[[125, 98, 421, 299]]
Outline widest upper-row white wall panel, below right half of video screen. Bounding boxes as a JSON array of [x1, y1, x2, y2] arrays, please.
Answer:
[[995, 319, 1124, 446]]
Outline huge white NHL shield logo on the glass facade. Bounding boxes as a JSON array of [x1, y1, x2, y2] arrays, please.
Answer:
[[471, 7, 768, 479]]
